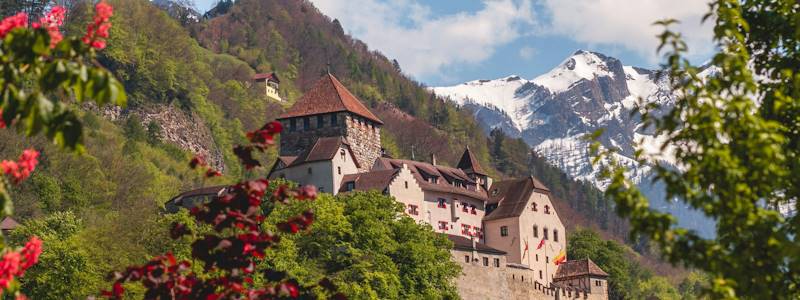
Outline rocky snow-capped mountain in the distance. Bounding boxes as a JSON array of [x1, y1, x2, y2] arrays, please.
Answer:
[[432, 50, 711, 237]]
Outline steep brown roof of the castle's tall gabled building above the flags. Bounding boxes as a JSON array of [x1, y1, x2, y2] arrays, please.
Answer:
[[483, 176, 550, 220]]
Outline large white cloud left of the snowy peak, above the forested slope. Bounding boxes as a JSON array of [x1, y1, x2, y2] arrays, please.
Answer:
[[312, 0, 534, 77]]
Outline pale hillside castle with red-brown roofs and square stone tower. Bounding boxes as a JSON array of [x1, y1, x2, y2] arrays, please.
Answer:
[[270, 74, 608, 299]]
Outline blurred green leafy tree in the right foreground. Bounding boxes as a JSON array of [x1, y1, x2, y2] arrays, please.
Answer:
[[593, 0, 800, 299]]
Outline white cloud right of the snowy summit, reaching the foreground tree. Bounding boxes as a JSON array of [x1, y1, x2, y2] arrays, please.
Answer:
[[537, 0, 713, 62]]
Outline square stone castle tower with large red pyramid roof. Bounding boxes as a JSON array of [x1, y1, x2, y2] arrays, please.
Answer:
[[278, 74, 383, 172]]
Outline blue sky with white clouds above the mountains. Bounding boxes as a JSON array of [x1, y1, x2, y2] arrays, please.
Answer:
[[195, 0, 713, 86]]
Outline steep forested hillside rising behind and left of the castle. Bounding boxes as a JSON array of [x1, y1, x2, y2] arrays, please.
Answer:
[[0, 0, 688, 298]]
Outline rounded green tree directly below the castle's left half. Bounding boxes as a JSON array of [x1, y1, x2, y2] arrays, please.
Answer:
[[266, 192, 460, 299]]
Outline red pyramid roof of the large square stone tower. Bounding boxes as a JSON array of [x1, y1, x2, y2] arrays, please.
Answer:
[[278, 74, 383, 124]]
